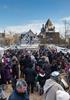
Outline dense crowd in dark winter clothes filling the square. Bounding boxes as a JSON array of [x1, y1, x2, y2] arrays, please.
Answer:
[[0, 48, 70, 100]]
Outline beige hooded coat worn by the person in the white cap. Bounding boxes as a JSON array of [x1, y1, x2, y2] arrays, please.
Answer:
[[43, 79, 64, 100]]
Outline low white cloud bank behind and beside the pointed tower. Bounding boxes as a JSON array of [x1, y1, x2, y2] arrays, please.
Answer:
[[0, 17, 70, 36]]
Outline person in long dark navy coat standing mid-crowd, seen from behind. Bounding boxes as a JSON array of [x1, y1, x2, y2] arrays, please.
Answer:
[[24, 64, 36, 93]]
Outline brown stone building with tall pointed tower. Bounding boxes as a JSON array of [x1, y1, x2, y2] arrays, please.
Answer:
[[39, 19, 60, 44]]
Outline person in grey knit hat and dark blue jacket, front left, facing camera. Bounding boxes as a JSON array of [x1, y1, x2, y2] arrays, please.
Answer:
[[8, 80, 29, 100]]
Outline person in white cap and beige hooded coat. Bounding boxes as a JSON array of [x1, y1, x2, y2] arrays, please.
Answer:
[[43, 71, 64, 100]]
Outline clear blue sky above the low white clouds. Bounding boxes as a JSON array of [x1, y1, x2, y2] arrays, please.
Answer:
[[0, 0, 70, 33]]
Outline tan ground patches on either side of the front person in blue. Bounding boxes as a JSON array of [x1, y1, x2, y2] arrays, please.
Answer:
[[6, 85, 43, 100]]
